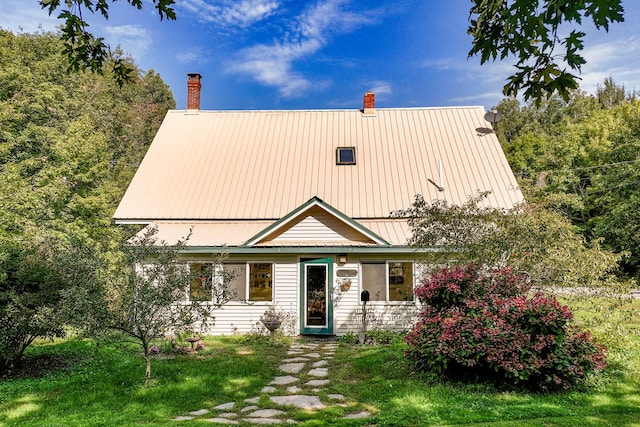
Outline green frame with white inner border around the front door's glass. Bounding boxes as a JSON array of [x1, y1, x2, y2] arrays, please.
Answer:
[[299, 257, 334, 335]]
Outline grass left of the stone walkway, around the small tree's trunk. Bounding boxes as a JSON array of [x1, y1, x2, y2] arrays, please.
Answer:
[[0, 337, 286, 426]]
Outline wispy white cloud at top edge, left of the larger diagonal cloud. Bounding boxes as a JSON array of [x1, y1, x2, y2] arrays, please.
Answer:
[[178, 0, 280, 27]]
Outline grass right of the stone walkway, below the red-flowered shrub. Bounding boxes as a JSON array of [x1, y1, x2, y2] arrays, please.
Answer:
[[332, 342, 640, 427]]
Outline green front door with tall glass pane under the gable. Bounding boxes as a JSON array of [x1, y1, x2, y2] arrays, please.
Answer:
[[300, 258, 333, 335]]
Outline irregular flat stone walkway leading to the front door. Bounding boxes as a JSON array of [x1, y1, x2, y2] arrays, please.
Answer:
[[173, 343, 371, 425]]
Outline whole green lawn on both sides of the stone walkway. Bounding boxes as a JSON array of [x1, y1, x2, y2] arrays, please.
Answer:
[[0, 305, 640, 427]]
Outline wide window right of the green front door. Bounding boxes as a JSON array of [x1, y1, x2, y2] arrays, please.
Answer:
[[362, 261, 413, 301]]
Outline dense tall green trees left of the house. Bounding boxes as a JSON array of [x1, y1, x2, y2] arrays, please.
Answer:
[[0, 30, 175, 368]]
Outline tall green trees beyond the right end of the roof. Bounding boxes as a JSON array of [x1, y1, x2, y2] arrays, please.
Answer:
[[496, 82, 640, 278]]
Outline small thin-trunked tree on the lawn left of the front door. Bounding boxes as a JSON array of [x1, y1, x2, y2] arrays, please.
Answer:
[[106, 229, 230, 383]]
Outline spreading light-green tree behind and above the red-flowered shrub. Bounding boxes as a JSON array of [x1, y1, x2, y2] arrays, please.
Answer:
[[395, 194, 620, 295]]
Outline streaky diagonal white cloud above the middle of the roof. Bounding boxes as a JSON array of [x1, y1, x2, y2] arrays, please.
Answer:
[[229, 0, 375, 97]]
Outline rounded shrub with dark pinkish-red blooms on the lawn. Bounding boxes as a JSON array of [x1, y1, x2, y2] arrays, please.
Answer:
[[405, 266, 606, 391]]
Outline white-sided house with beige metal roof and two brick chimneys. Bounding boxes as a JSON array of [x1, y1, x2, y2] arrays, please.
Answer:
[[114, 74, 523, 335]]
